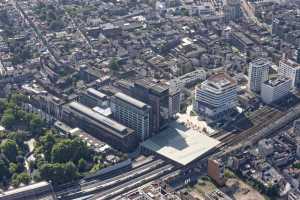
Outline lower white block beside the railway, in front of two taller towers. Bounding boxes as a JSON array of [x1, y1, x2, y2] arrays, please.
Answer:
[[260, 76, 292, 104]]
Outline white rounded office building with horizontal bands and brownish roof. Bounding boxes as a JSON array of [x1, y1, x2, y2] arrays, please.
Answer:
[[194, 73, 237, 118]]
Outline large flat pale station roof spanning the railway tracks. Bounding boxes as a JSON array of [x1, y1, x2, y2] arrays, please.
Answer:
[[142, 122, 220, 165]]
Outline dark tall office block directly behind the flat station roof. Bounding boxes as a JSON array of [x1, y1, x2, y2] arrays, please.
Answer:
[[133, 79, 169, 133]]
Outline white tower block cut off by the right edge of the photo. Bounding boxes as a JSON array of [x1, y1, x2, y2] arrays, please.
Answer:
[[278, 56, 300, 88]]
